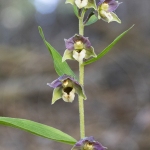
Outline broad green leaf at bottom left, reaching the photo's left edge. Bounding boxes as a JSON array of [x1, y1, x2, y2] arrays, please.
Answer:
[[0, 117, 76, 145]]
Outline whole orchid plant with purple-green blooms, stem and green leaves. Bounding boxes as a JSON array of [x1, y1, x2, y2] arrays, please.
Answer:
[[0, 0, 133, 150]]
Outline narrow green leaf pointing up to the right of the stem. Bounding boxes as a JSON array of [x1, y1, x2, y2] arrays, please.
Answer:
[[84, 25, 134, 65]]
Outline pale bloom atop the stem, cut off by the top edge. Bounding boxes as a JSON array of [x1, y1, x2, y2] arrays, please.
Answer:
[[66, 0, 96, 9]]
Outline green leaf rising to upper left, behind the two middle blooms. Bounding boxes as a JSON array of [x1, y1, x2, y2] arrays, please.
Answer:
[[38, 26, 76, 78]]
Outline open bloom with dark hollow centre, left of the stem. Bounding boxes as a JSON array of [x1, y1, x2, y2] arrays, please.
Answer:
[[47, 75, 86, 104]]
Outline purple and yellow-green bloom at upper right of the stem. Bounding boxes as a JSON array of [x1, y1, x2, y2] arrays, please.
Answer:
[[98, 0, 121, 23]]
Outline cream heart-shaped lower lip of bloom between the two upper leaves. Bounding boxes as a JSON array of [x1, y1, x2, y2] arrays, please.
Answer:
[[73, 49, 86, 64]]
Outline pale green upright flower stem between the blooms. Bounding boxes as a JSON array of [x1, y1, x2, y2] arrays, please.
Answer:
[[78, 9, 85, 138]]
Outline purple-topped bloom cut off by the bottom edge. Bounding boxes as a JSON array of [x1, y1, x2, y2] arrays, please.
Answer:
[[71, 136, 107, 150]]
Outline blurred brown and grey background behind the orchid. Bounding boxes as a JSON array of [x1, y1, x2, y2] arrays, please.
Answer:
[[0, 0, 150, 150]]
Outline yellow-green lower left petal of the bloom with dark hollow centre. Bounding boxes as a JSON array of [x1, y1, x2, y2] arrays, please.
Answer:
[[52, 87, 62, 104]]
